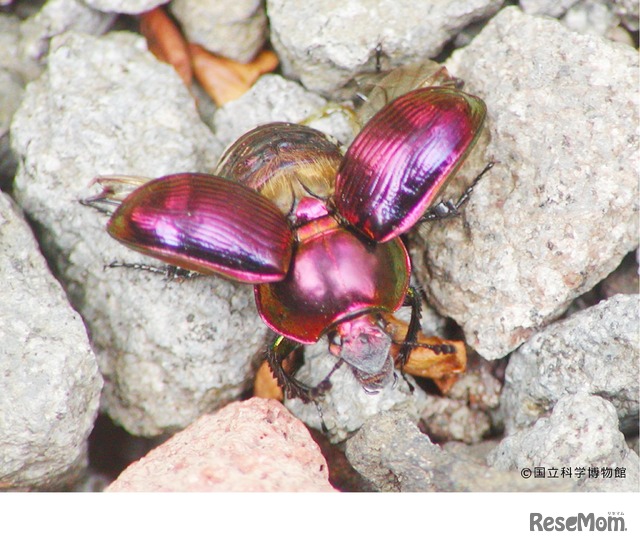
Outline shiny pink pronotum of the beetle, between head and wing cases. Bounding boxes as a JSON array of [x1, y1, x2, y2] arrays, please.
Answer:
[[255, 216, 411, 343]]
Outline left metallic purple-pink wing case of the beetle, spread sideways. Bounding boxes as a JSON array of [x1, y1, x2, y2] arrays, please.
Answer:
[[107, 173, 293, 283]]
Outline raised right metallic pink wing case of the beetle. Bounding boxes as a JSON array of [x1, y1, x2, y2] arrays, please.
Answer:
[[334, 87, 486, 242]]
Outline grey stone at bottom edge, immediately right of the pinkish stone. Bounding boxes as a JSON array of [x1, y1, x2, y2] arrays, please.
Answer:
[[346, 411, 573, 492]]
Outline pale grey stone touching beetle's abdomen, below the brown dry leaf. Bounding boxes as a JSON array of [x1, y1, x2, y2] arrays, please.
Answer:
[[214, 74, 354, 150]]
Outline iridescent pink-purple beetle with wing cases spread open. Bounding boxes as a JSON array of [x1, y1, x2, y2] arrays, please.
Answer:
[[89, 67, 491, 401]]
